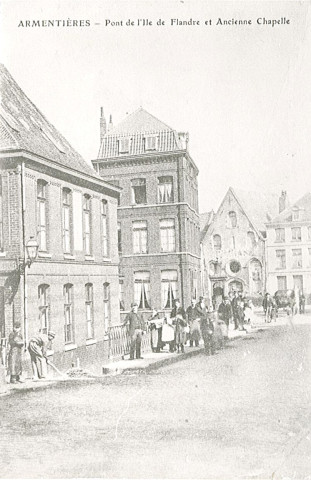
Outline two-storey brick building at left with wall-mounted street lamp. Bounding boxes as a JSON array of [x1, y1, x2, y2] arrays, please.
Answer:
[[0, 66, 120, 367]]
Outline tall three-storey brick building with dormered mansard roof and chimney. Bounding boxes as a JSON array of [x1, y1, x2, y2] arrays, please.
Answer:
[[93, 108, 200, 315]]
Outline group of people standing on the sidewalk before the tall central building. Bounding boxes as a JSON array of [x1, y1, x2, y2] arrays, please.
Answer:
[[123, 297, 219, 360]]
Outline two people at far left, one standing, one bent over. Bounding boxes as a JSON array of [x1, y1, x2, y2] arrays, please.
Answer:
[[8, 322, 55, 383]]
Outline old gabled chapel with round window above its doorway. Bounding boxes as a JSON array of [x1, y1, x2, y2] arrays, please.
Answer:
[[201, 188, 278, 302]]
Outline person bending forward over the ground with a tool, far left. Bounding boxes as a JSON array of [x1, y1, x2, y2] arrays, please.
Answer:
[[28, 331, 55, 379]]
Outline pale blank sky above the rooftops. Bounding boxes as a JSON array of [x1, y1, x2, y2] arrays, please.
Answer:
[[0, 0, 311, 212]]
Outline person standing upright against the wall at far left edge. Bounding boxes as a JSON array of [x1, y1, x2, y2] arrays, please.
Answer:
[[8, 322, 24, 383]]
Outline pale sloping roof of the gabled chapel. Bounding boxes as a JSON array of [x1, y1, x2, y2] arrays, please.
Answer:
[[231, 188, 279, 232]]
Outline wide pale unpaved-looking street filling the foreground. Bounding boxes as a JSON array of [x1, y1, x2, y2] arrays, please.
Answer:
[[0, 316, 311, 480]]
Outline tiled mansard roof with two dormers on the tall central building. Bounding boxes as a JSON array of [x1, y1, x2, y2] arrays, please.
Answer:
[[97, 108, 184, 159]]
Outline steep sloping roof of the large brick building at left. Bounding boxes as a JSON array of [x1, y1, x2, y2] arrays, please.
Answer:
[[0, 64, 99, 178]]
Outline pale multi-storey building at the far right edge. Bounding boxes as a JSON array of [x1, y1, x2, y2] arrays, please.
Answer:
[[266, 192, 311, 301]]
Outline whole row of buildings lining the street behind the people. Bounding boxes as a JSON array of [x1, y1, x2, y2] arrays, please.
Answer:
[[0, 66, 311, 367]]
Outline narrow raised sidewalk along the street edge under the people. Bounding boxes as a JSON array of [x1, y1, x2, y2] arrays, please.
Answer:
[[0, 328, 257, 398]]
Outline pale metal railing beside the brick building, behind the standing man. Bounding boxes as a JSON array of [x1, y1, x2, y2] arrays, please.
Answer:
[[108, 324, 151, 360]]
